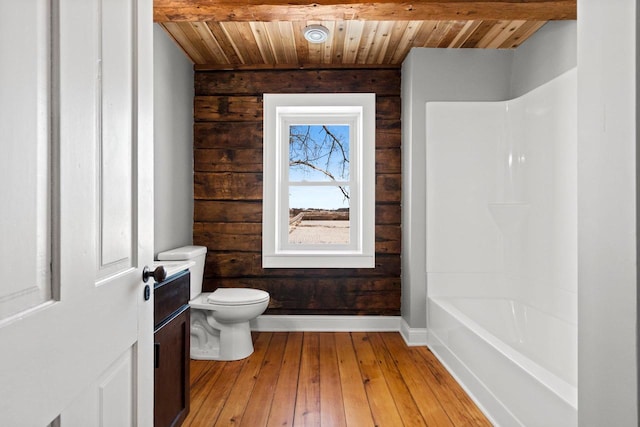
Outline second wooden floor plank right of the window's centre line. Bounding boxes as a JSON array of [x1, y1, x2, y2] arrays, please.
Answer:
[[335, 333, 375, 427]]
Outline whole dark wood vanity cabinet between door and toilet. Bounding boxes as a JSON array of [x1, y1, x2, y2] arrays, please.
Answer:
[[153, 271, 190, 427]]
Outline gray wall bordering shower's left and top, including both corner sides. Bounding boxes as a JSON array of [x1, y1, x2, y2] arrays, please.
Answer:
[[402, 22, 577, 329]]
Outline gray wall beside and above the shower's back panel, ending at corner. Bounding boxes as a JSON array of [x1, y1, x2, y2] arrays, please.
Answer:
[[402, 49, 513, 329]]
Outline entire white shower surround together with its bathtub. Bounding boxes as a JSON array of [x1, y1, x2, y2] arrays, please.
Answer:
[[426, 69, 577, 426]]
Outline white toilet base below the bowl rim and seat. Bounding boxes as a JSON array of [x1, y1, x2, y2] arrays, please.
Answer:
[[190, 308, 253, 361]]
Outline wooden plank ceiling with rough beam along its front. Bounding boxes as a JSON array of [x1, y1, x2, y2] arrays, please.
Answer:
[[154, 0, 576, 69]]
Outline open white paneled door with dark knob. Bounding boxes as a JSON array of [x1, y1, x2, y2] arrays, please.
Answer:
[[0, 0, 153, 427]]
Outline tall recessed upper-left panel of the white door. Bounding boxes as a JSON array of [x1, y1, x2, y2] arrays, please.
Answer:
[[0, 0, 52, 322]]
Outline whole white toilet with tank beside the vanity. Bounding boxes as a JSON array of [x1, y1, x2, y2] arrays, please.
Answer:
[[158, 246, 269, 360]]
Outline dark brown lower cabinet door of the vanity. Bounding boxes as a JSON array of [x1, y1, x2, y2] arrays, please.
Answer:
[[154, 307, 190, 427]]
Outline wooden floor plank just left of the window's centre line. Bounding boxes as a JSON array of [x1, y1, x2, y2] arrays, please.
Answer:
[[293, 332, 321, 427]]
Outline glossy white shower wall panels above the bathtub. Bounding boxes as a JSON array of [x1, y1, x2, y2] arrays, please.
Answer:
[[426, 68, 578, 326]]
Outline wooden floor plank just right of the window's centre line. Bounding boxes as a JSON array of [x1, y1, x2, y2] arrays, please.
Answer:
[[320, 332, 346, 427]]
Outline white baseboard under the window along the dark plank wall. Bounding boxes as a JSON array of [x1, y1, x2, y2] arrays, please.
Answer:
[[251, 315, 402, 332]]
